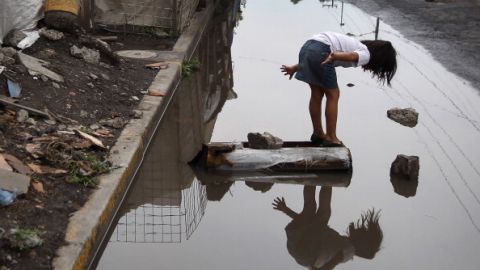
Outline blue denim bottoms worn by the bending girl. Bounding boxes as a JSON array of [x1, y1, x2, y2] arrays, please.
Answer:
[[295, 40, 338, 89]]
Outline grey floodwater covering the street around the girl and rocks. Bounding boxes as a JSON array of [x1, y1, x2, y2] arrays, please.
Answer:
[[97, 0, 480, 270]]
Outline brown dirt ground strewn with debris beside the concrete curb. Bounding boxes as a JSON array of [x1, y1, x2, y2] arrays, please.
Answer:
[[0, 26, 175, 270]]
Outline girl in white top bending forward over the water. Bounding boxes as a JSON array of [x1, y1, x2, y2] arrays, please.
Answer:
[[281, 32, 397, 147]]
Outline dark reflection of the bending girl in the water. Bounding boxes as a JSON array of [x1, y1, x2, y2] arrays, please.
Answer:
[[273, 186, 383, 269]]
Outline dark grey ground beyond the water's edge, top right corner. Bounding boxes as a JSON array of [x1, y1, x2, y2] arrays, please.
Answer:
[[348, 0, 480, 91]]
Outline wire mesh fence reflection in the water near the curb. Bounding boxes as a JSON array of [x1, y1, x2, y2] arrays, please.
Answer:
[[110, 180, 207, 243]]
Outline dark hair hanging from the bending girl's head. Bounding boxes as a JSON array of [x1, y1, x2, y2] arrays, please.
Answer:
[[361, 40, 397, 86]]
